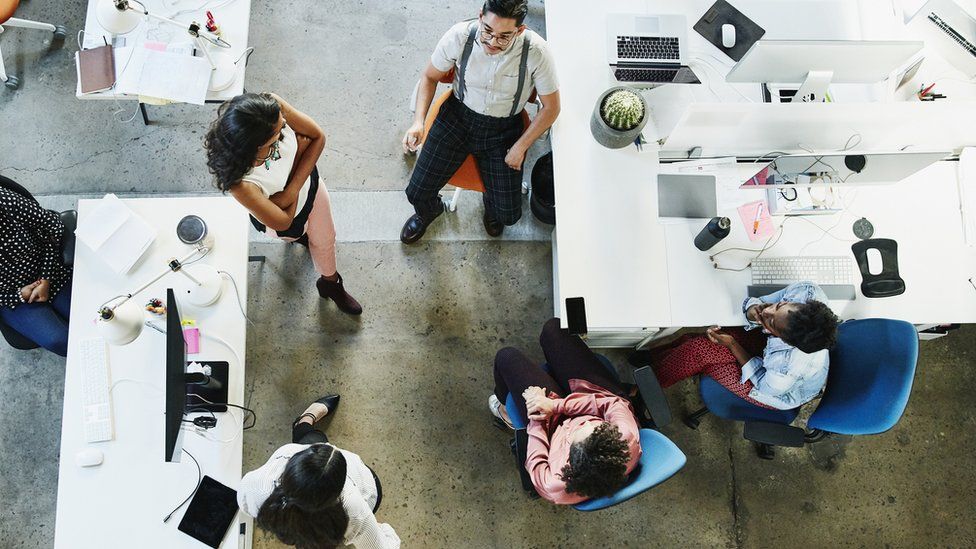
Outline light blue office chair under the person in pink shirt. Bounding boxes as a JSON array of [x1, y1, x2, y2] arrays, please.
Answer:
[[505, 355, 687, 511]]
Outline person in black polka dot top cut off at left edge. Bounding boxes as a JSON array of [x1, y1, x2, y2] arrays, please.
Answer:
[[0, 184, 71, 356]]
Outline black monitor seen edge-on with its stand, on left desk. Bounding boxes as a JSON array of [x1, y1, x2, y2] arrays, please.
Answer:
[[165, 288, 228, 462]]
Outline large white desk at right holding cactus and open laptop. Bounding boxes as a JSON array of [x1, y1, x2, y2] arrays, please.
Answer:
[[546, 0, 976, 347]]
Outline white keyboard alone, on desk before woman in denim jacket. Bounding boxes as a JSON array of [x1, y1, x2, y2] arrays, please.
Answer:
[[752, 256, 854, 286]]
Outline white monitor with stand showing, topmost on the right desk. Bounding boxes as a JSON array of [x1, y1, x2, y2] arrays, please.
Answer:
[[725, 40, 925, 102]]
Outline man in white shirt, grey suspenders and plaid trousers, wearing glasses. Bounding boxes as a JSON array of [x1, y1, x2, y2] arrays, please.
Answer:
[[400, 0, 559, 244]]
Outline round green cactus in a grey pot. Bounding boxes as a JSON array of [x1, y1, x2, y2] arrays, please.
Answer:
[[590, 86, 650, 149]]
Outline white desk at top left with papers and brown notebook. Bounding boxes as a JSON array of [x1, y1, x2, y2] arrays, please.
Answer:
[[75, 0, 251, 102]]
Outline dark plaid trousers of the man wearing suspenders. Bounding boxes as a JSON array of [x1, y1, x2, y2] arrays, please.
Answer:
[[406, 95, 523, 225]]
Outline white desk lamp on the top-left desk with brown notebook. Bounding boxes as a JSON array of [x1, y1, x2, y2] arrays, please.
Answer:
[[95, 0, 237, 91]]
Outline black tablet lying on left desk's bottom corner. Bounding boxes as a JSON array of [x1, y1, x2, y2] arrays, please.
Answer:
[[179, 476, 237, 548]]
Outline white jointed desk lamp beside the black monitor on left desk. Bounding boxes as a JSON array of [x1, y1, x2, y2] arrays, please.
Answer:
[[98, 215, 223, 345]]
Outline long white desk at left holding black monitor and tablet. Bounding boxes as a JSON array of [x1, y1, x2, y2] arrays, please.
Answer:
[[54, 198, 251, 549]]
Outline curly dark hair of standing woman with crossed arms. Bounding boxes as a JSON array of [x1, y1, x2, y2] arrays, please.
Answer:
[[203, 93, 281, 192]]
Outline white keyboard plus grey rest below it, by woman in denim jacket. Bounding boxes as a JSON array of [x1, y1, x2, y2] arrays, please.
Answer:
[[749, 256, 857, 300]]
